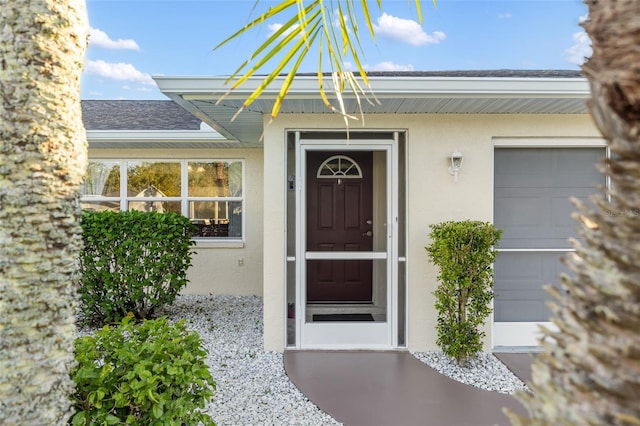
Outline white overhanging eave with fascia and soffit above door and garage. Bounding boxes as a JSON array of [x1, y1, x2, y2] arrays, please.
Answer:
[[154, 71, 589, 146]]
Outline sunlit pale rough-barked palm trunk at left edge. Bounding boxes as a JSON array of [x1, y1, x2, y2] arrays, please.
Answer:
[[0, 0, 88, 425]]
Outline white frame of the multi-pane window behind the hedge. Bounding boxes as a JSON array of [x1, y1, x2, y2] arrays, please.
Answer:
[[80, 157, 247, 248]]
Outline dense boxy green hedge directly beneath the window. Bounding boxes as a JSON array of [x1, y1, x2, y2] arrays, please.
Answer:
[[80, 211, 194, 324]]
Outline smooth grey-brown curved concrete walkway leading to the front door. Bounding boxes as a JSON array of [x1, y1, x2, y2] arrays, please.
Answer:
[[284, 351, 526, 426]]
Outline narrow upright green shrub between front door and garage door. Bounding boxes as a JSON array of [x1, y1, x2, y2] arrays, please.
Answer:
[[426, 220, 502, 363]]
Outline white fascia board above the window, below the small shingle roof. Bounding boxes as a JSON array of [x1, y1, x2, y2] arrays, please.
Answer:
[[87, 130, 232, 143]]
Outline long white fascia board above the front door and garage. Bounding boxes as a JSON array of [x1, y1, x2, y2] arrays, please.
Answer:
[[154, 76, 590, 100]]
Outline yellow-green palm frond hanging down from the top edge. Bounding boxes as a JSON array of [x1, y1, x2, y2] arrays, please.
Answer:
[[215, 0, 436, 125]]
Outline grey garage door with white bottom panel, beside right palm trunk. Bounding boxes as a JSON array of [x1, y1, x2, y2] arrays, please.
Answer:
[[494, 148, 605, 346]]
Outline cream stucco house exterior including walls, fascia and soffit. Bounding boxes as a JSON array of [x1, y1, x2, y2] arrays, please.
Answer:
[[88, 75, 602, 351]]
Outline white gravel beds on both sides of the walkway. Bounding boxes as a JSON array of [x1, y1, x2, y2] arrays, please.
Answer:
[[80, 295, 526, 426]]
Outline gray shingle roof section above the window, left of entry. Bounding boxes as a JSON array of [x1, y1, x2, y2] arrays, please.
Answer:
[[82, 100, 200, 130]]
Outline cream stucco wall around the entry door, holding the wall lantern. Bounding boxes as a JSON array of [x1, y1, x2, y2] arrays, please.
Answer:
[[264, 114, 599, 351]]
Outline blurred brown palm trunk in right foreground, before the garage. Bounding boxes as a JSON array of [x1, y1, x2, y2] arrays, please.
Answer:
[[512, 0, 640, 426]]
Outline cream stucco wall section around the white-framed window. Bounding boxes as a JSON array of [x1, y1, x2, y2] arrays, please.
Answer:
[[89, 148, 264, 296]]
